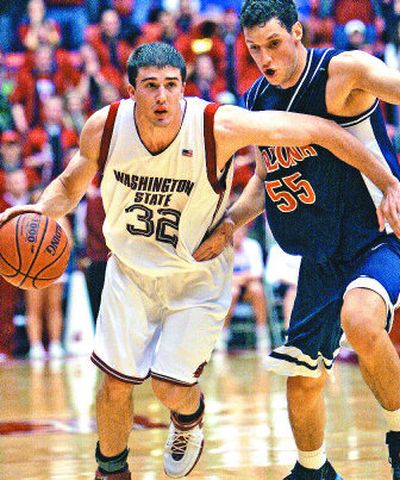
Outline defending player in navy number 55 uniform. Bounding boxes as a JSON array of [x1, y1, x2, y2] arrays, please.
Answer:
[[195, 0, 400, 480]]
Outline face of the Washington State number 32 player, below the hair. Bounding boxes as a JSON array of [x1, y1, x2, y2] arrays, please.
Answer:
[[129, 66, 184, 127]]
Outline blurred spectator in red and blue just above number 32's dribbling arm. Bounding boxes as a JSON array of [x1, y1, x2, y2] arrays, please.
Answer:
[[24, 97, 79, 185]]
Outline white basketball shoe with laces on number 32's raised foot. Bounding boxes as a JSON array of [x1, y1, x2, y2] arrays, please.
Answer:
[[164, 415, 204, 478]]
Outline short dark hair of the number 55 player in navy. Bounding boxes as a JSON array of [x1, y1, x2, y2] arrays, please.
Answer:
[[240, 0, 299, 32]]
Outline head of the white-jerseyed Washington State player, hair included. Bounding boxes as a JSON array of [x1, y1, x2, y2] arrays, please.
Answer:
[[128, 43, 186, 127]]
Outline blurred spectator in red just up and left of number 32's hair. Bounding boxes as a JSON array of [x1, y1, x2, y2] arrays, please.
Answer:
[[87, 10, 132, 72]]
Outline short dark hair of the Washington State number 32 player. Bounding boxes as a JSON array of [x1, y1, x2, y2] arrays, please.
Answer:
[[128, 42, 186, 86]]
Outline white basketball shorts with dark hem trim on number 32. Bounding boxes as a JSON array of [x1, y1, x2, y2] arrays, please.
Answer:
[[91, 255, 232, 385]]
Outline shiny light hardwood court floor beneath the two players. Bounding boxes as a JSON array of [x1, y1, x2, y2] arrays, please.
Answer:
[[0, 354, 391, 480]]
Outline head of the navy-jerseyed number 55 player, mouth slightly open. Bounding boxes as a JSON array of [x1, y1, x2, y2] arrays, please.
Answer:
[[240, 0, 304, 88]]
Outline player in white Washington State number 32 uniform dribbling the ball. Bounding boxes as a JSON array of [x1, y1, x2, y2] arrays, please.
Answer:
[[0, 43, 400, 480]]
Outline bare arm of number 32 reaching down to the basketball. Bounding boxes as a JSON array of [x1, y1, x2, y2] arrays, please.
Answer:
[[0, 109, 107, 225]]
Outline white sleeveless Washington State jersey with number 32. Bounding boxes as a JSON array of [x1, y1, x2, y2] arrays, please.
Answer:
[[101, 98, 233, 276]]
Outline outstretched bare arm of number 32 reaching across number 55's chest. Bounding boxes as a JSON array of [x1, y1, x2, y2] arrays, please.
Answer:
[[216, 106, 397, 193]]
